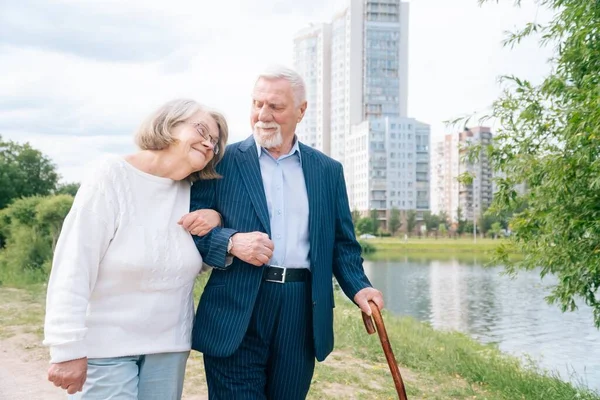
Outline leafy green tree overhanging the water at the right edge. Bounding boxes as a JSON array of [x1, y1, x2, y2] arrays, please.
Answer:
[[473, 0, 600, 327]]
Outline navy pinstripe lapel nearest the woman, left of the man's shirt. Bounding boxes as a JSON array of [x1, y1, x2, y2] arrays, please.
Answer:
[[236, 137, 271, 236]]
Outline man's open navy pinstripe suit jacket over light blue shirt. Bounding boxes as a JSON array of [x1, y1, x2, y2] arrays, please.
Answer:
[[191, 137, 371, 396]]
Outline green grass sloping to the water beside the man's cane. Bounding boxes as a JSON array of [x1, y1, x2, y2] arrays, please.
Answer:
[[335, 295, 600, 400]]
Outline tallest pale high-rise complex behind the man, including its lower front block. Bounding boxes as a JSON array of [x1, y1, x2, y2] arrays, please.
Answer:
[[294, 0, 430, 225]]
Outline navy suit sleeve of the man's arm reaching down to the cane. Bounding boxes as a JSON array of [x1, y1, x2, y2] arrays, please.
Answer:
[[333, 167, 371, 300]]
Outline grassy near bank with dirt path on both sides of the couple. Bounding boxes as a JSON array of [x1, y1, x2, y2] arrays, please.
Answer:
[[0, 283, 600, 400]]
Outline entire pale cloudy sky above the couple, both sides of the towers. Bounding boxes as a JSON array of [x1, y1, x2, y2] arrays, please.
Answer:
[[0, 0, 551, 181]]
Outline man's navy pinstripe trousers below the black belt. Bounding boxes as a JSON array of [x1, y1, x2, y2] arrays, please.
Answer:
[[199, 281, 315, 400]]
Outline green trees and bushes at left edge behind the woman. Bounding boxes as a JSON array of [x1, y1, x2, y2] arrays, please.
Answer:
[[0, 136, 79, 284]]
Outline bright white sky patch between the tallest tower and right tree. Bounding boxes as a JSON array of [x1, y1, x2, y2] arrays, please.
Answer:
[[408, 0, 551, 139]]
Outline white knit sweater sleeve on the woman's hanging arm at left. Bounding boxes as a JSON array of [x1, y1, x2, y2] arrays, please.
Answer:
[[44, 161, 119, 363]]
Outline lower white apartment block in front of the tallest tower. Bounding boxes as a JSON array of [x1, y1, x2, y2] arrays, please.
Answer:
[[344, 117, 430, 228]]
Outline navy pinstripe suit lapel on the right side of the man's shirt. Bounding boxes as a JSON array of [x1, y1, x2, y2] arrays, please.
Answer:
[[300, 143, 324, 265]]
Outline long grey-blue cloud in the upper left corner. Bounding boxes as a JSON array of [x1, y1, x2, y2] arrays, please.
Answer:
[[0, 0, 185, 62]]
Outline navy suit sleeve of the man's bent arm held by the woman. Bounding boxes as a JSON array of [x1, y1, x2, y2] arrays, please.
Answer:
[[190, 179, 237, 269]]
